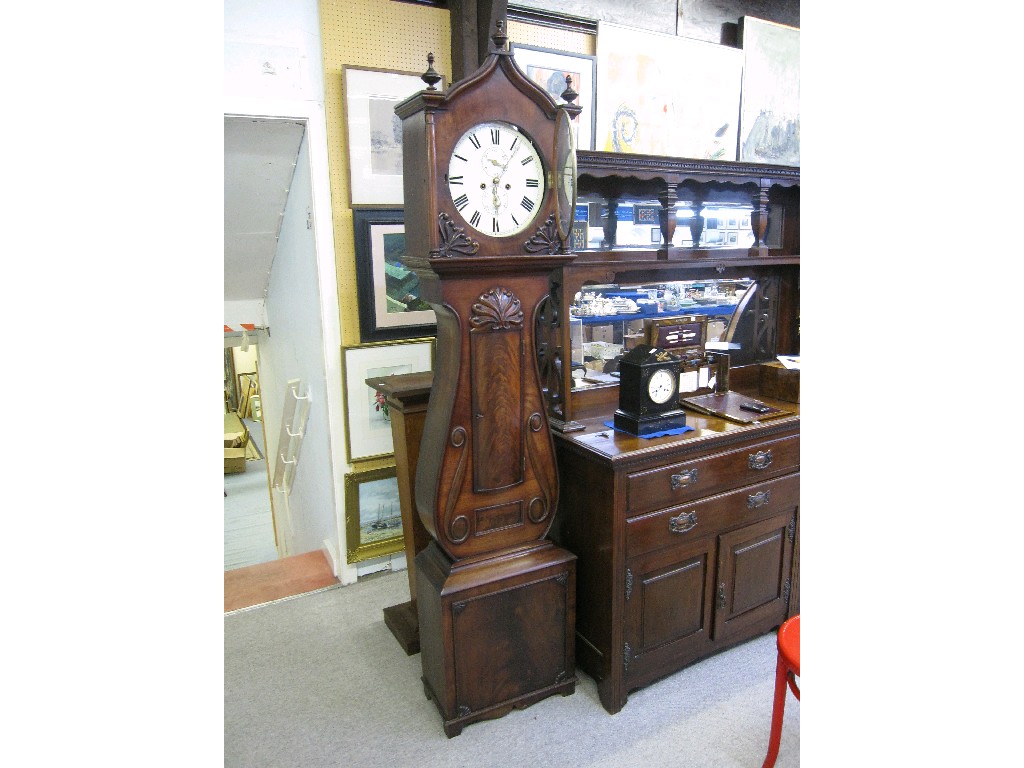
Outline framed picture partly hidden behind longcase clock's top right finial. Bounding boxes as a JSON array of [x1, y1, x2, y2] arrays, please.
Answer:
[[512, 45, 597, 150]]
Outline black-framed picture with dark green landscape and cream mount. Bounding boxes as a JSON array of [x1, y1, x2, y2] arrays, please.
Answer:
[[352, 208, 437, 342]]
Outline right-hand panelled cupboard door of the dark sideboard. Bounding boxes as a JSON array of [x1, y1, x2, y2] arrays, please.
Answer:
[[715, 509, 797, 641]]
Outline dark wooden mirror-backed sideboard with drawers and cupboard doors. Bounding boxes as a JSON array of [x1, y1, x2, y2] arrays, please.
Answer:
[[538, 152, 800, 713]]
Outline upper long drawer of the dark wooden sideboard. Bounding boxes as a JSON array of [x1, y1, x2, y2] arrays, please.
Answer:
[[626, 435, 800, 516]]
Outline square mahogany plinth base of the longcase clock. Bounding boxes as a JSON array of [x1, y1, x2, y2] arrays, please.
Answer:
[[416, 540, 577, 738]]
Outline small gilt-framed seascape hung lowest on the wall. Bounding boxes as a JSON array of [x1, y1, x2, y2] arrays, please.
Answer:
[[345, 466, 404, 564]]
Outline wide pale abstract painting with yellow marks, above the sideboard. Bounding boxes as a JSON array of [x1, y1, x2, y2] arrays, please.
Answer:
[[595, 22, 743, 160]]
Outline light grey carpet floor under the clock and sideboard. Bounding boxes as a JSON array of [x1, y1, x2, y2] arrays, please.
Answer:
[[224, 571, 800, 768]]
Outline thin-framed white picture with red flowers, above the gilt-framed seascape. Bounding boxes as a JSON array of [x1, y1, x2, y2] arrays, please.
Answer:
[[341, 339, 434, 462]]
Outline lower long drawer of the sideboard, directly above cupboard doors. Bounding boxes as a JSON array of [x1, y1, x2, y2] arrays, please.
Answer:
[[626, 475, 800, 558]]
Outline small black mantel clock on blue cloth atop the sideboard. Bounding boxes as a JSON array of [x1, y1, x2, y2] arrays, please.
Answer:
[[612, 344, 686, 437]]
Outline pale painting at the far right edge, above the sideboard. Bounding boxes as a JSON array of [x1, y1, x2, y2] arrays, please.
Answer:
[[739, 16, 800, 166]]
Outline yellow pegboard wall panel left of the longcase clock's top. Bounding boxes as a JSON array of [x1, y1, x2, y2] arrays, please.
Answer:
[[319, 0, 452, 344]]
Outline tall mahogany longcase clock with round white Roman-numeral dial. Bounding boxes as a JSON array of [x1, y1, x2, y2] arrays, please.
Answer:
[[395, 22, 580, 736]]
